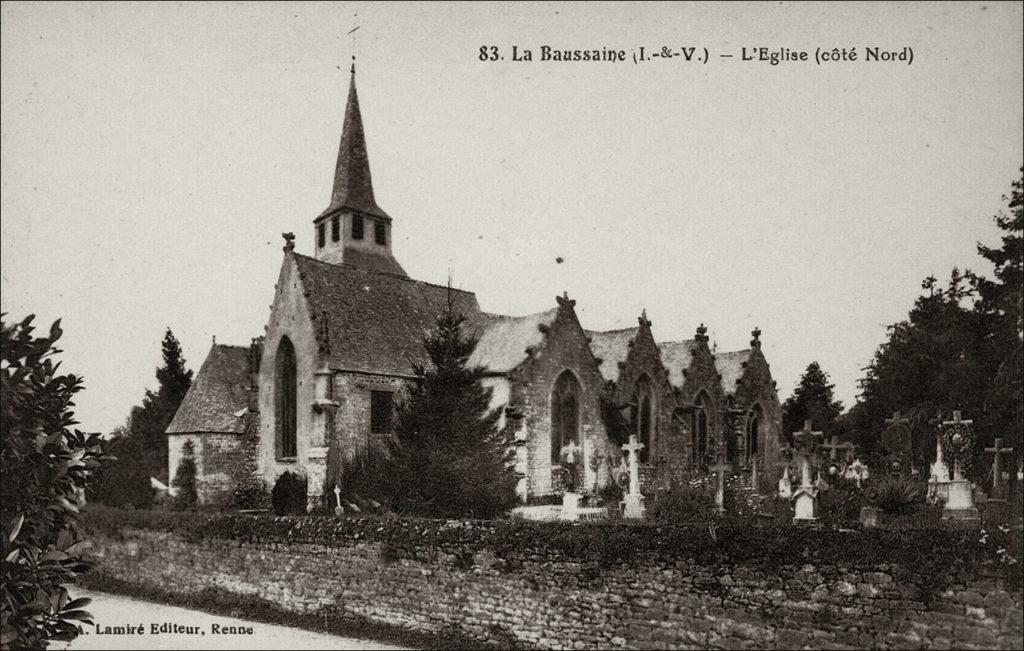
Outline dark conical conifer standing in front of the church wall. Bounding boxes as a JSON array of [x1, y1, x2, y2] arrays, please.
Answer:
[[389, 297, 519, 518]]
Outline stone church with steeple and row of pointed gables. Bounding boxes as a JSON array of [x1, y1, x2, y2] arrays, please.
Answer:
[[167, 67, 784, 506]]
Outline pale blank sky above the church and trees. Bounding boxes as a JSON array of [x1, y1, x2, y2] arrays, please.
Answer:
[[0, 2, 1024, 432]]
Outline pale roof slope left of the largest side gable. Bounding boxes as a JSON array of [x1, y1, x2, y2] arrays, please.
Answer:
[[469, 307, 558, 373]]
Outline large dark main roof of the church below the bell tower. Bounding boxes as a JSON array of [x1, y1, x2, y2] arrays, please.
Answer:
[[293, 254, 481, 376]]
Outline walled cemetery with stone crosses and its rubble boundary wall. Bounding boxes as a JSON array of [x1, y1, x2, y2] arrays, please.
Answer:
[[79, 413, 1024, 648]]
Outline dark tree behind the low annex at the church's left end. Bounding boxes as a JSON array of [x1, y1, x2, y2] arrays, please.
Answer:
[[94, 329, 193, 509]]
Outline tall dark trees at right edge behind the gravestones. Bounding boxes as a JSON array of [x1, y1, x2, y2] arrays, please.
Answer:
[[844, 168, 1024, 481]]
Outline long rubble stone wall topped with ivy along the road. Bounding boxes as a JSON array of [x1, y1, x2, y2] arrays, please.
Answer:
[[87, 511, 1022, 649]]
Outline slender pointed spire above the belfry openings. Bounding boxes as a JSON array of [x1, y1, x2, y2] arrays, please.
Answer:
[[321, 67, 388, 218]]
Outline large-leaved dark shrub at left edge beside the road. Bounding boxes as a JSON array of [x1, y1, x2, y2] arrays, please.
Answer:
[[0, 316, 106, 649]]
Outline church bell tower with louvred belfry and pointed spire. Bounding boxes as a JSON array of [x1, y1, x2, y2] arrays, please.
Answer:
[[313, 63, 407, 276]]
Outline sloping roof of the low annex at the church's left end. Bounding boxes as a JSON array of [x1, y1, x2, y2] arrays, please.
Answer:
[[167, 344, 249, 434]]
